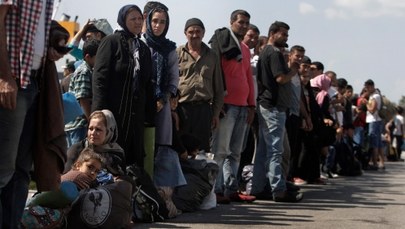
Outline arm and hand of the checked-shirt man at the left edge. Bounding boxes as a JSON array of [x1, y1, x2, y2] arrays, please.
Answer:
[[0, 5, 18, 110]]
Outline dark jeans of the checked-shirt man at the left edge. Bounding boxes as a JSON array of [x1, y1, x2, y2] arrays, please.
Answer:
[[0, 79, 38, 228]]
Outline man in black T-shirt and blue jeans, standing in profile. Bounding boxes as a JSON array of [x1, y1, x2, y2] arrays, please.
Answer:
[[252, 21, 302, 202]]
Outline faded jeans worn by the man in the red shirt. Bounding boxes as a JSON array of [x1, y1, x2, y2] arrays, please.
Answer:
[[212, 104, 248, 195]]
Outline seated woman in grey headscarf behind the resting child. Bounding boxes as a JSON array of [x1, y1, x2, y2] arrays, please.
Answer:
[[64, 110, 125, 176]]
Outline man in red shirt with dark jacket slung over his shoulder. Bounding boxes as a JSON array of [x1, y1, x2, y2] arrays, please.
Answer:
[[209, 10, 255, 202]]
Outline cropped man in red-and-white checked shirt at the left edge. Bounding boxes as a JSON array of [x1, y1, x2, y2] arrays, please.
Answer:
[[0, 0, 69, 228]]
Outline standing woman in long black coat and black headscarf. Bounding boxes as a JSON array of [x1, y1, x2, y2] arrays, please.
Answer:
[[92, 5, 154, 167]]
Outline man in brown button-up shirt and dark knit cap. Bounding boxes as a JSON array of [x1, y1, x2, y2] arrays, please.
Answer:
[[177, 18, 224, 152]]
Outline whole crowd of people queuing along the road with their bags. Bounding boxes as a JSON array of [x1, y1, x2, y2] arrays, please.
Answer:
[[0, 0, 404, 228]]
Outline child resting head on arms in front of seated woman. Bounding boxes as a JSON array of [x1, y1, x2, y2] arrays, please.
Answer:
[[62, 148, 105, 190]]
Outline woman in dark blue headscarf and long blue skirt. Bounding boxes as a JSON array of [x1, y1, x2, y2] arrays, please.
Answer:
[[143, 7, 186, 216]]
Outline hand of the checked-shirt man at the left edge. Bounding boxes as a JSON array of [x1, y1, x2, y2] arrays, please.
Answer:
[[0, 76, 18, 110]]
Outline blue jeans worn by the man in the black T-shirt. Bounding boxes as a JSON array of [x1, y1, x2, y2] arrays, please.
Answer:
[[252, 106, 286, 195]]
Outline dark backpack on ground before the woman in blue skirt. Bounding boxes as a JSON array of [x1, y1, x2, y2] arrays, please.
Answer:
[[127, 164, 169, 223]]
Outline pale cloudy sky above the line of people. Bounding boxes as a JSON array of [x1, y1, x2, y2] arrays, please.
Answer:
[[55, 0, 405, 103]]
